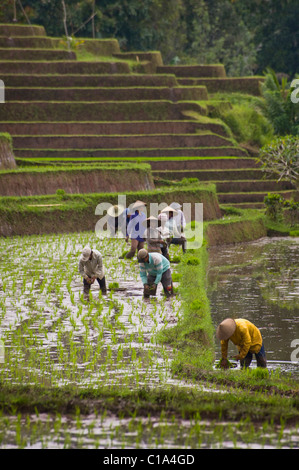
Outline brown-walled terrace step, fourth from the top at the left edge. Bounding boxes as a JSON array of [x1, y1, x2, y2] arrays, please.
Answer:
[[0, 61, 130, 75]]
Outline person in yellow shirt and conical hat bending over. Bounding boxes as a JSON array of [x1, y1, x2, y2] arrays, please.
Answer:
[[216, 318, 267, 369]]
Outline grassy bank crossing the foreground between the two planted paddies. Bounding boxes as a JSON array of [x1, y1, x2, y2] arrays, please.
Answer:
[[0, 382, 299, 424]]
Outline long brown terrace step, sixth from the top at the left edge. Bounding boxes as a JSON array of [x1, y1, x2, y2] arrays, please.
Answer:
[[5, 86, 208, 101]]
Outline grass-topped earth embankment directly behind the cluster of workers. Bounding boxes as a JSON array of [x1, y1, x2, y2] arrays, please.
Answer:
[[0, 186, 221, 237]]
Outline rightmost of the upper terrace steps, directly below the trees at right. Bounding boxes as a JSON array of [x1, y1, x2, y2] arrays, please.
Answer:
[[177, 76, 265, 96]]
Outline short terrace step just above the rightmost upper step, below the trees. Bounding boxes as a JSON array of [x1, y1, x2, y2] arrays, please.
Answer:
[[157, 64, 226, 78]]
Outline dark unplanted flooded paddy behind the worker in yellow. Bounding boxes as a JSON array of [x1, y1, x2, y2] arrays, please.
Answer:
[[208, 238, 299, 372]]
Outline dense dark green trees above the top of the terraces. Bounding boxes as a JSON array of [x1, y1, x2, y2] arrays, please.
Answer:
[[0, 0, 299, 78]]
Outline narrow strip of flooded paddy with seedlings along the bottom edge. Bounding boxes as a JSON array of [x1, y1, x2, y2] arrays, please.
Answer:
[[0, 414, 299, 449]]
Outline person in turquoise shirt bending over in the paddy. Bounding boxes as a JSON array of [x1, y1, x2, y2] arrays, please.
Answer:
[[137, 248, 173, 297]]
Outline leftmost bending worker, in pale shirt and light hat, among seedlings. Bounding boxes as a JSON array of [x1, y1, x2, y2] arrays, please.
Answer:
[[79, 246, 107, 299]]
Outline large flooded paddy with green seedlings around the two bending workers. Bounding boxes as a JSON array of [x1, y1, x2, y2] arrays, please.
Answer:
[[0, 234, 183, 387]]
